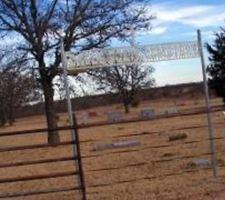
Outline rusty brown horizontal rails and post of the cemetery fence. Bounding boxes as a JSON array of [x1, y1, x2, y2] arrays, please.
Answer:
[[0, 106, 225, 200]]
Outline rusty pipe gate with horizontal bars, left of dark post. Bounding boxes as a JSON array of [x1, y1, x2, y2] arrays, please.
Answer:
[[0, 117, 86, 200]]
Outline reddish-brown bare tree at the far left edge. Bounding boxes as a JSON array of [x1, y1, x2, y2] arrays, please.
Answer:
[[0, 51, 39, 126]]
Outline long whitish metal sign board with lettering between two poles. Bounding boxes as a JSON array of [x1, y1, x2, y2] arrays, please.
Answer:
[[66, 41, 200, 73]]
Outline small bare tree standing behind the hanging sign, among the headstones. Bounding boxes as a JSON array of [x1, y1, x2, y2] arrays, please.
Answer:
[[89, 65, 155, 113]]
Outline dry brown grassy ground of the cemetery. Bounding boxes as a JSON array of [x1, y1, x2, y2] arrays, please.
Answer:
[[0, 99, 225, 200]]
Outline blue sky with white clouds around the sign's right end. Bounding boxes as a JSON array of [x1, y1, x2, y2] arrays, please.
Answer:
[[114, 0, 225, 86]]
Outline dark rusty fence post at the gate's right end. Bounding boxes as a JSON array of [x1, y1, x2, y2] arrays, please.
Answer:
[[73, 113, 87, 200]]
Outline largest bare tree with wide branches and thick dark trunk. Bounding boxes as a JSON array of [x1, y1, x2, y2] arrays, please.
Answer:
[[0, 0, 152, 145]]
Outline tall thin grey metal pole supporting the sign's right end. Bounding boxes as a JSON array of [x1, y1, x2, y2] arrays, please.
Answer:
[[197, 30, 218, 178]]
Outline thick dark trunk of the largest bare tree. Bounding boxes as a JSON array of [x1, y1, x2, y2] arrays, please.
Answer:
[[42, 81, 60, 146]]
